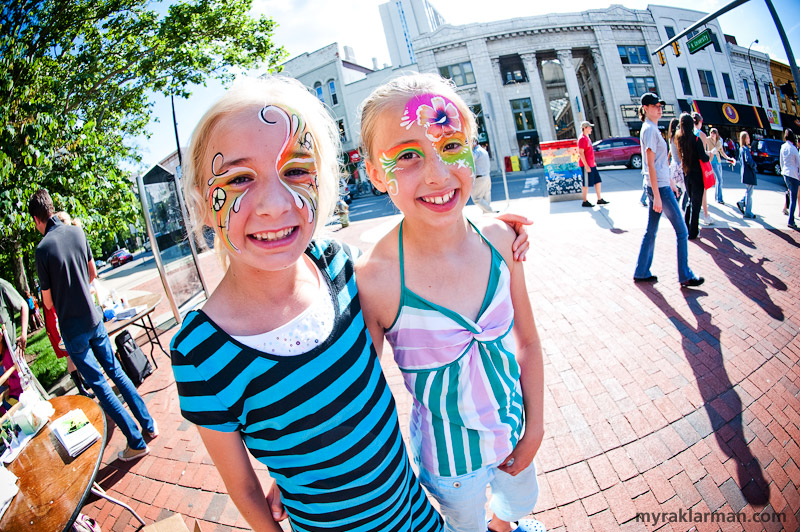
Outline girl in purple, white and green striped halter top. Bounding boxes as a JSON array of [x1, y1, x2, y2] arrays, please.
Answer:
[[356, 74, 544, 532]]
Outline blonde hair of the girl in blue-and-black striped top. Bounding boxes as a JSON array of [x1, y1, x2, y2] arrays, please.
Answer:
[[182, 76, 341, 263]]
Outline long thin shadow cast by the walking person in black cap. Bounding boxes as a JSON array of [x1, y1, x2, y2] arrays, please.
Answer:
[[637, 285, 770, 511]]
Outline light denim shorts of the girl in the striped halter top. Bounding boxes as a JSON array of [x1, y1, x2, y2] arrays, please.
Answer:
[[419, 462, 539, 532]]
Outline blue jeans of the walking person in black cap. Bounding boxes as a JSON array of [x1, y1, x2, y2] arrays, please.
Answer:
[[633, 187, 694, 283]]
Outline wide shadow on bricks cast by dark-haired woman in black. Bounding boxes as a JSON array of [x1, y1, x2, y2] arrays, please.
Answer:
[[694, 229, 787, 321]]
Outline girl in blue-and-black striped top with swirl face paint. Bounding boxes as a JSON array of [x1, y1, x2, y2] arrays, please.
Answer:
[[171, 77, 442, 532]]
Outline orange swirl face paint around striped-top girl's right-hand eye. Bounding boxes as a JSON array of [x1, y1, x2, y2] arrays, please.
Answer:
[[258, 105, 319, 231]]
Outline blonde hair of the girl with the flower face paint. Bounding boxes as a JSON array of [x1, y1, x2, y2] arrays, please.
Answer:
[[359, 74, 478, 160]]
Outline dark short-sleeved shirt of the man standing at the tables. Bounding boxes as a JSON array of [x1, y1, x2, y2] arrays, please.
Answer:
[[36, 216, 102, 339]]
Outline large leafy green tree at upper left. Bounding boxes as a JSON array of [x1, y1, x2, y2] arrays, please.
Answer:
[[0, 0, 285, 290]]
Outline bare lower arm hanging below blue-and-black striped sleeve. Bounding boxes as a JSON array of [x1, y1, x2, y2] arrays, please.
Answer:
[[197, 426, 287, 532]]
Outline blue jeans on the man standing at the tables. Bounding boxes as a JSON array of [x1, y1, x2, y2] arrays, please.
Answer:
[[62, 322, 155, 450]]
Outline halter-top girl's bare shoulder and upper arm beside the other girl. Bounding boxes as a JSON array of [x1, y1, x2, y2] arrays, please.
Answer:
[[356, 228, 400, 357]]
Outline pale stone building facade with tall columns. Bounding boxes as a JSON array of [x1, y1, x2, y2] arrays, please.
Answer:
[[413, 5, 677, 167]]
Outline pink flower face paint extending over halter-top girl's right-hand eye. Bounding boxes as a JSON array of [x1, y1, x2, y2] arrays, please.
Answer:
[[400, 94, 475, 175]]
